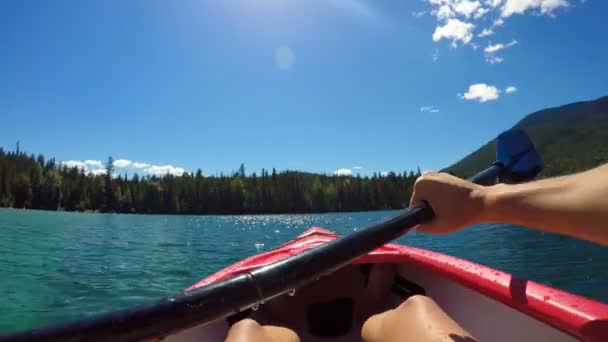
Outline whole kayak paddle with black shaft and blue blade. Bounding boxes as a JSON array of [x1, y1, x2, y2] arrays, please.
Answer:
[[0, 130, 542, 341]]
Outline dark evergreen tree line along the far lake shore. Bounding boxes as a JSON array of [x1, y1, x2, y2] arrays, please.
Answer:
[[0, 148, 420, 214]]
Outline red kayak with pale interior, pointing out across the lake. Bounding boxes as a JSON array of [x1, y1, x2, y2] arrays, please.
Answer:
[[162, 228, 608, 341]]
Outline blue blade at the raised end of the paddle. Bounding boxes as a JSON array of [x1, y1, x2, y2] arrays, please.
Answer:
[[496, 129, 543, 183]]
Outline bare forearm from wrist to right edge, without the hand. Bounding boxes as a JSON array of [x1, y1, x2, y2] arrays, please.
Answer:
[[481, 165, 608, 245]]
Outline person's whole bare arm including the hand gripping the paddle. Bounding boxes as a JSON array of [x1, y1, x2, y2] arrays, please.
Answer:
[[411, 164, 608, 245]]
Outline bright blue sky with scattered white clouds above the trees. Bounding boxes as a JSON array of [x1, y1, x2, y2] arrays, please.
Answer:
[[0, 0, 608, 174]]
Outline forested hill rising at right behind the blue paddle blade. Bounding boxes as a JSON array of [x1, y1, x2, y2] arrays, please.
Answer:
[[445, 96, 608, 177]]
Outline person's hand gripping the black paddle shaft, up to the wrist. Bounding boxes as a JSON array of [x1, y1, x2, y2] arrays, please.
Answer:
[[410, 172, 484, 234]]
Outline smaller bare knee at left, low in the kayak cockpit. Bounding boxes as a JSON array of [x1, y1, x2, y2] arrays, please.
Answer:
[[226, 318, 300, 342]]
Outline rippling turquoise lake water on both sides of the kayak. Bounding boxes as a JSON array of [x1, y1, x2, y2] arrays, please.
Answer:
[[0, 209, 608, 333]]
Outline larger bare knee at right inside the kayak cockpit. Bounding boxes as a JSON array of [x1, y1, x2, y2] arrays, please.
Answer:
[[361, 296, 476, 342]]
